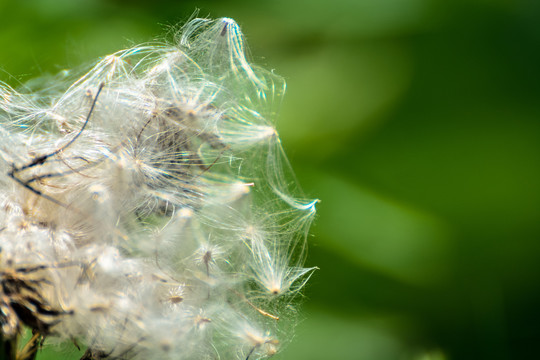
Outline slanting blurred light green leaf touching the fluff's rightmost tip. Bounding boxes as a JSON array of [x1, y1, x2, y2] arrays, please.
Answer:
[[309, 172, 451, 284]]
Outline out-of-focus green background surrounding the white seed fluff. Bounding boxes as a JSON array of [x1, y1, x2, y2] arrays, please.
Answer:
[[0, 0, 540, 360]]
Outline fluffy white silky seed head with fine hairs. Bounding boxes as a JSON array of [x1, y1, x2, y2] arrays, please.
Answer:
[[0, 18, 316, 360]]
